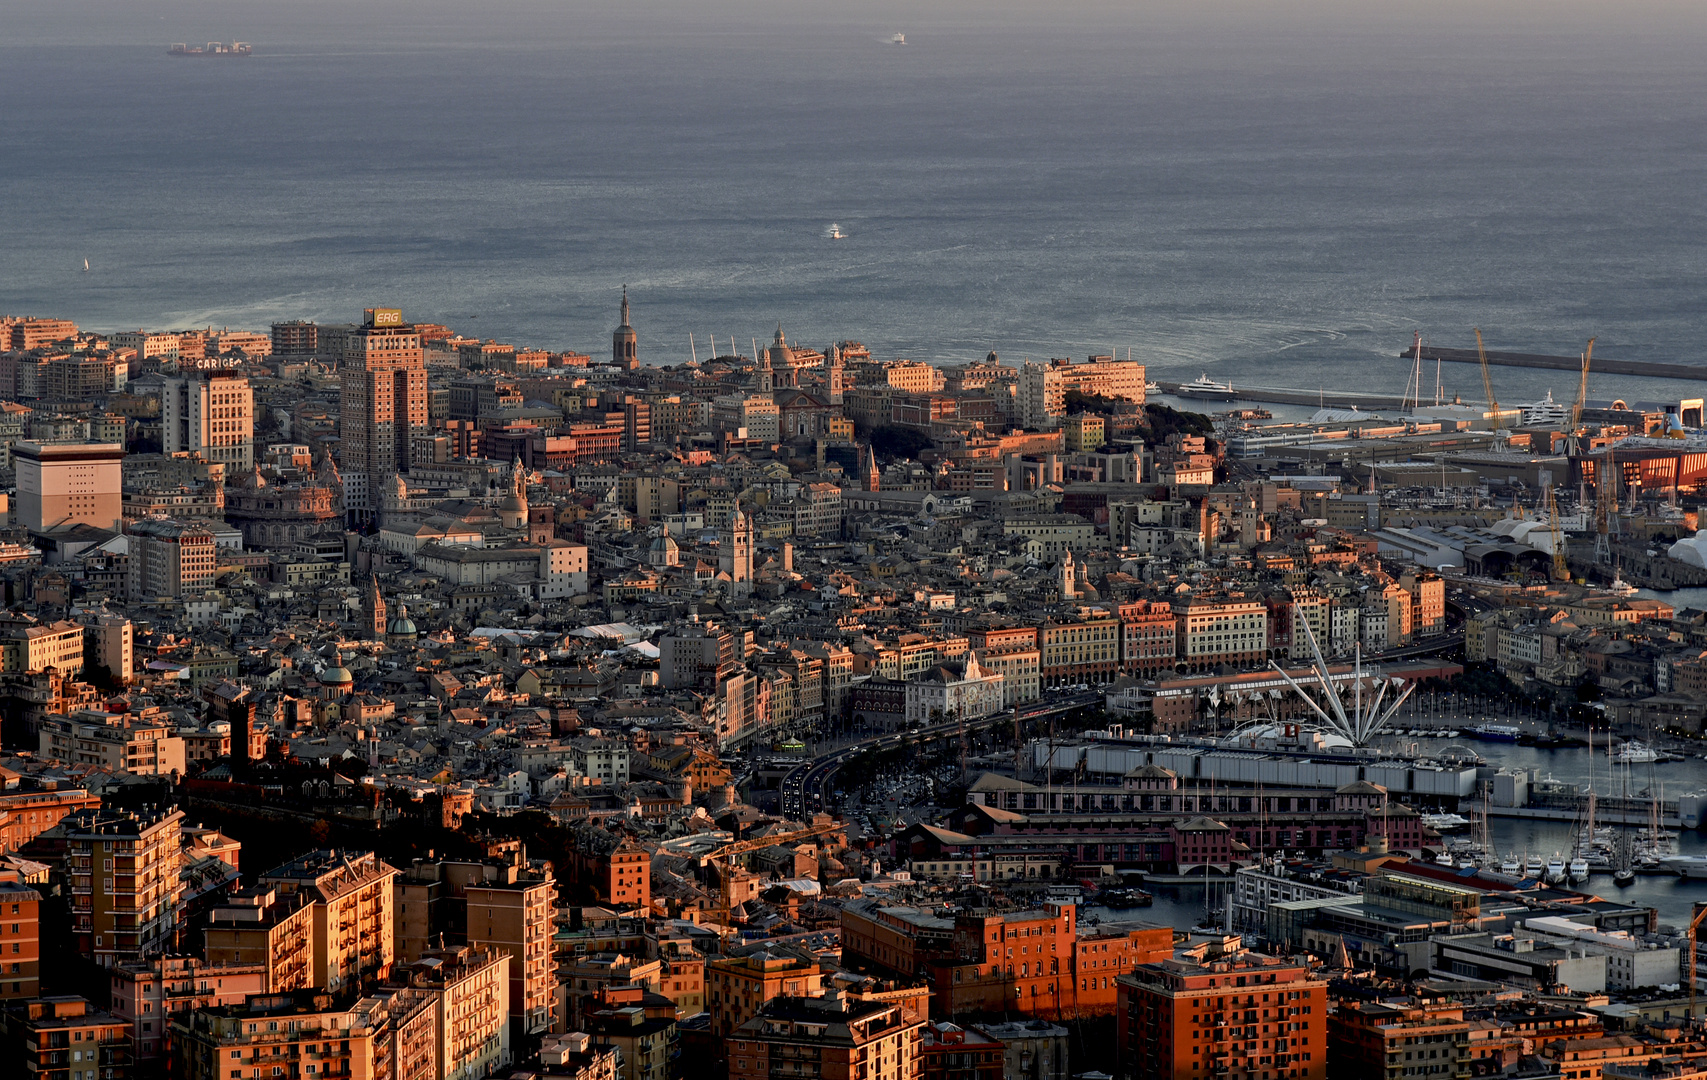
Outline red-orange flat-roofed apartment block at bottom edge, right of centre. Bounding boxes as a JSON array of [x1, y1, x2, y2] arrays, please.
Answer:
[[1115, 937, 1328, 1080]]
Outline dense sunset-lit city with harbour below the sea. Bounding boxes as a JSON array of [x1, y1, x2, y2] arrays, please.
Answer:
[[0, 290, 1707, 1080]]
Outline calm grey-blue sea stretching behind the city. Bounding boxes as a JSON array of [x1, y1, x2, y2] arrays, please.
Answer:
[[0, 0, 1707, 401]]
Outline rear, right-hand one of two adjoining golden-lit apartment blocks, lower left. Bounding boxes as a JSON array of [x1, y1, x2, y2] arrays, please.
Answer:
[[256, 850, 398, 991]]
